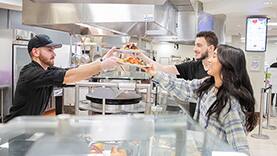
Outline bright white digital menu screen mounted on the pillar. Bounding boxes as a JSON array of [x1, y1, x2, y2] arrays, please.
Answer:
[[245, 17, 268, 52]]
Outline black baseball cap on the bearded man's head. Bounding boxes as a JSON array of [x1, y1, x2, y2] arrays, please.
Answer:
[[28, 34, 62, 53]]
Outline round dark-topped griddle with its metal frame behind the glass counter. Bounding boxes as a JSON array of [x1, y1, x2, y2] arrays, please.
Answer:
[[75, 80, 151, 114]]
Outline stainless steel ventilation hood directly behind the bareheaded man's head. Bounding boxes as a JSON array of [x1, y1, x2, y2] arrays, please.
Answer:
[[151, 0, 226, 45]]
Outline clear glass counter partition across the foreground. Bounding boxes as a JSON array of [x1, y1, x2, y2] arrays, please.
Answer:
[[0, 114, 246, 156]]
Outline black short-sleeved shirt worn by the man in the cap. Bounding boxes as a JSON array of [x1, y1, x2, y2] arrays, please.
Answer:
[[5, 61, 67, 122]]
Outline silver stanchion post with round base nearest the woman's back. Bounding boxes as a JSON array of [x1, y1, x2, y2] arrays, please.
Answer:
[[251, 88, 269, 139]]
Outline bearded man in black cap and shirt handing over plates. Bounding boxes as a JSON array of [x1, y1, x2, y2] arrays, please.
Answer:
[[4, 34, 118, 122]]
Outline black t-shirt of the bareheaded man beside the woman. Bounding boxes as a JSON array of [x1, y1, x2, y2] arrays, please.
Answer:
[[176, 60, 208, 80]]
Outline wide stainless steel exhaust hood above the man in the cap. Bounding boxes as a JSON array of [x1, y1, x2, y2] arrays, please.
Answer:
[[22, 0, 176, 37]]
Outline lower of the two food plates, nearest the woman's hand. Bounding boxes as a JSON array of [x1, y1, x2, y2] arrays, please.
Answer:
[[118, 56, 150, 68]]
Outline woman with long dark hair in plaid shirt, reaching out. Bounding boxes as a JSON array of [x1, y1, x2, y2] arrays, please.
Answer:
[[145, 45, 257, 153]]
